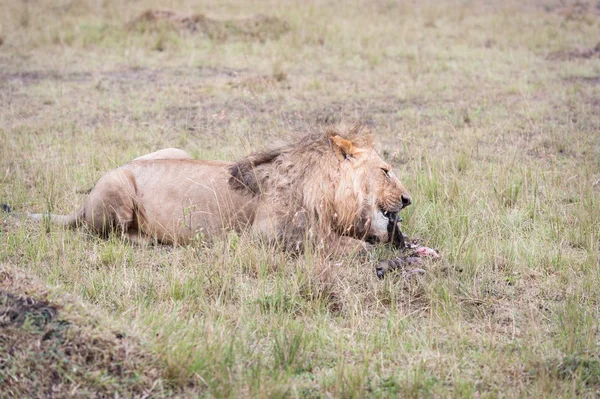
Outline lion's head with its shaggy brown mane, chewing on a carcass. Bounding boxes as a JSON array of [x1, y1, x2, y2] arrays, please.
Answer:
[[229, 125, 411, 248]]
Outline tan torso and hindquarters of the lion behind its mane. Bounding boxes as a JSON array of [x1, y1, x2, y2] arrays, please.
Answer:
[[58, 159, 256, 244]]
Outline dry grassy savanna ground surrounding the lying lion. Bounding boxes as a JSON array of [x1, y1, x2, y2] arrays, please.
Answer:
[[0, 0, 600, 397]]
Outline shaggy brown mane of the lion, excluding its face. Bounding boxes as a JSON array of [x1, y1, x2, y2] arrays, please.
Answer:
[[229, 124, 372, 245]]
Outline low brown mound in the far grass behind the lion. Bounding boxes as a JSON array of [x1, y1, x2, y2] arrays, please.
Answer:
[[127, 9, 290, 41]]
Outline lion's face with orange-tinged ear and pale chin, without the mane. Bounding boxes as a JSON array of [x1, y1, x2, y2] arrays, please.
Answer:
[[331, 136, 411, 242]]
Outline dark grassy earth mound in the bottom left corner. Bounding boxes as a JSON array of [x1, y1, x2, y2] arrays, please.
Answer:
[[0, 265, 188, 398]]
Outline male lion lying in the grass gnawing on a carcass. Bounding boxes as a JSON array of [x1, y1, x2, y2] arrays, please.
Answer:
[[12, 125, 411, 253]]
